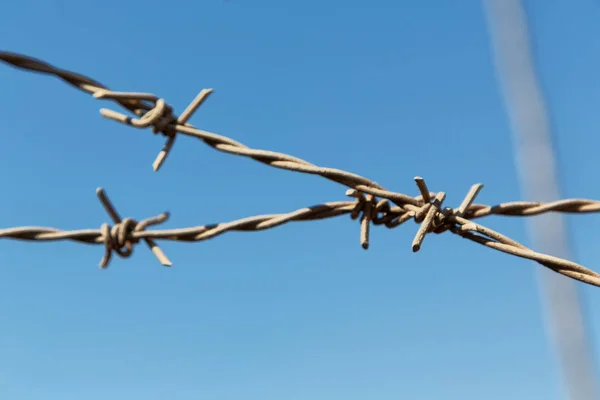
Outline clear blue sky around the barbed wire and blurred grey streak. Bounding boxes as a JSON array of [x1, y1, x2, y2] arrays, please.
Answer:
[[0, 0, 600, 400]]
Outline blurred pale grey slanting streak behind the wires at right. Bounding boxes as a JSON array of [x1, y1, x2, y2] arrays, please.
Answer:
[[484, 0, 598, 400]]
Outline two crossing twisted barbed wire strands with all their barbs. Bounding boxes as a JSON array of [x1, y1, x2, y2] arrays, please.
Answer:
[[0, 52, 600, 287]]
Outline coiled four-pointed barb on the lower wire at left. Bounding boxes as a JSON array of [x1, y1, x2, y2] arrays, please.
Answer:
[[96, 188, 171, 269]]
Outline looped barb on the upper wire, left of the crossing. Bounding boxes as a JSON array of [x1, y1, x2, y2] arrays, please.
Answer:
[[94, 89, 213, 171]]
